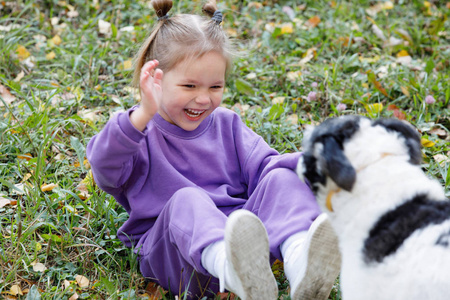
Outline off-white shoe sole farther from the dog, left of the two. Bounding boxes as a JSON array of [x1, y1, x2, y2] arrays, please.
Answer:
[[225, 210, 278, 300]]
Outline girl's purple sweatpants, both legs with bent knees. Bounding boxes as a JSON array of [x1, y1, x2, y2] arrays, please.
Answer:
[[139, 168, 320, 299]]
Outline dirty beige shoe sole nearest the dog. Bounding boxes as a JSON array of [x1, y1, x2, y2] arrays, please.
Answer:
[[291, 214, 341, 300]]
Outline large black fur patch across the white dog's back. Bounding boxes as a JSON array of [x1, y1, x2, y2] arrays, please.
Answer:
[[364, 194, 450, 263]]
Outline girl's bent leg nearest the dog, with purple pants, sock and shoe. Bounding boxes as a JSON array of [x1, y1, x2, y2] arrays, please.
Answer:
[[244, 169, 341, 300]]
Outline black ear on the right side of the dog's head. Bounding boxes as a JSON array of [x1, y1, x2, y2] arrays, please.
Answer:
[[373, 119, 422, 165]]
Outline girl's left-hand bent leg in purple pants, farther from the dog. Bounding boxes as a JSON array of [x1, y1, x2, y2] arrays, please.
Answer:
[[140, 188, 227, 299]]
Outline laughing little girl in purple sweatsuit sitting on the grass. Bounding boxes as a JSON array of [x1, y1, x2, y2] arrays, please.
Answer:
[[87, 0, 340, 300]]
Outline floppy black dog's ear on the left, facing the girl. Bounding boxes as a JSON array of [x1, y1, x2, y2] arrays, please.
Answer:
[[322, 136, 356, 191]]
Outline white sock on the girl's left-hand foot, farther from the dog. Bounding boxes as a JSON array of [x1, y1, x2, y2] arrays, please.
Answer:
[[202, 240, 242, 296]]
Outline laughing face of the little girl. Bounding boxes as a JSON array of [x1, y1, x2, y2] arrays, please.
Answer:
[[158, 51, 226, 131]]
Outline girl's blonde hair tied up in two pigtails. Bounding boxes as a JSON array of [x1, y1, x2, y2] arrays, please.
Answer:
[[132, 0, 234, 87]]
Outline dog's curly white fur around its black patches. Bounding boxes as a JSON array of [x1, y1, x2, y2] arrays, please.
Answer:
[[297, 118, 450, 300]]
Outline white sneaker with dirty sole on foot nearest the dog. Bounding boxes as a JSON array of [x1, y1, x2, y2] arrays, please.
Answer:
[[285, 214, 341, 300]]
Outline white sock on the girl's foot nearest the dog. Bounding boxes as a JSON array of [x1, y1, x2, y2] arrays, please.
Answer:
[[280, 230, 308, 290]]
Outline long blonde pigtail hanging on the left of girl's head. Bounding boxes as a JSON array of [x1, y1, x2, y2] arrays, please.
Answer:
[[131, 0, 173, 88]]
